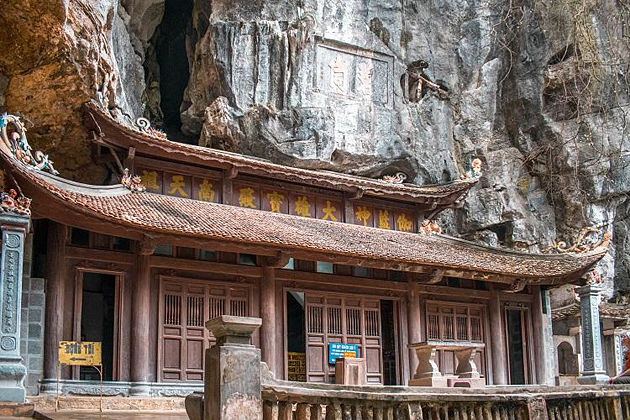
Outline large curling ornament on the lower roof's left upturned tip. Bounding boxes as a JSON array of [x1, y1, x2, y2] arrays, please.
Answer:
[[0, 112, 59, 175]]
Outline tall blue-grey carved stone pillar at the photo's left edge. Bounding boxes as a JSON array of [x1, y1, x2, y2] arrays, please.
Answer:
[[0, 212, 30, 403]]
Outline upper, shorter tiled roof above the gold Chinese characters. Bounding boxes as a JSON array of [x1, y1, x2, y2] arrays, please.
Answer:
[[85, 102, 477, 204]]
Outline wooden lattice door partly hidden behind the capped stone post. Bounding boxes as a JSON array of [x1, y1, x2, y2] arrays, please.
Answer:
[[158, 279, 249, 382]]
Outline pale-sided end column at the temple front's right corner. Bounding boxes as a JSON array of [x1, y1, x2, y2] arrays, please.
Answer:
[[532, 286, 556, 385]]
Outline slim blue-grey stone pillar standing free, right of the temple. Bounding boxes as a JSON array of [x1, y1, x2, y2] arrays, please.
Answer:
[[576, 284, 609, 384]]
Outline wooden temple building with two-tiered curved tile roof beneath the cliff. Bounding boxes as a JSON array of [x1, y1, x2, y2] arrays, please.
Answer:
[[1, 103, 609, 396]]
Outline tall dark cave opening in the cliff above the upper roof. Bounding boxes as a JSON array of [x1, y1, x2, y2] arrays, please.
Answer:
[[155, 0, 196, 143]]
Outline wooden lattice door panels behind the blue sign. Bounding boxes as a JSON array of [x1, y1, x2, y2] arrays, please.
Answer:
[[305, 293, 383, 383]]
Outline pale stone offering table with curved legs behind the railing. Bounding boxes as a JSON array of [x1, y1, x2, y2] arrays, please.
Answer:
[[409, 340, 486, 388]]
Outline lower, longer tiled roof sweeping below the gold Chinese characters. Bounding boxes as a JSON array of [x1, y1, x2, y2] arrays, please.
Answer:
[[3, 154, 606, 282]]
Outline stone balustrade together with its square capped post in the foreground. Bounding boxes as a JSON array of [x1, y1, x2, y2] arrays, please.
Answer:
[[186, 316, 630, 420]]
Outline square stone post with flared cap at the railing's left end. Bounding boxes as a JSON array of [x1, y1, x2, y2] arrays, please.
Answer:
[[203, 315, 262, 420]]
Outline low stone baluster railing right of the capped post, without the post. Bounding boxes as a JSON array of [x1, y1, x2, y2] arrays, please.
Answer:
[[262, 381, 630, 420]]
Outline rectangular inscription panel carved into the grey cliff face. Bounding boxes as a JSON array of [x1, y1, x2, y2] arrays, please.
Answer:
[[315, 43, 393, 105]]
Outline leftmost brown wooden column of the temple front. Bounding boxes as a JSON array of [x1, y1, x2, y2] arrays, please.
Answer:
[[44, 221, 68, 380]]
